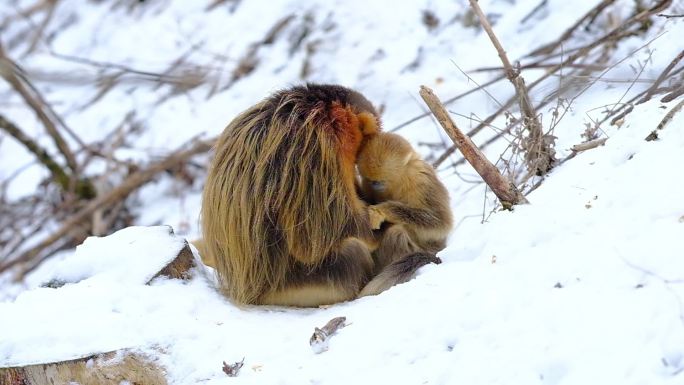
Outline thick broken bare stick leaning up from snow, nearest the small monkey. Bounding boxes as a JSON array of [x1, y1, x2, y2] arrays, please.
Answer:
[[420, 86, 527, 209]]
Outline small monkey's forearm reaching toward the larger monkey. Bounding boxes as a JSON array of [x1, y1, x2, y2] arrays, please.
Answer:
[[368, 201, 445, 228]]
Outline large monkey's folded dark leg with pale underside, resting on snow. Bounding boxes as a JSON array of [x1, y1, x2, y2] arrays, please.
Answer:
[[259, 238, 374, 307]]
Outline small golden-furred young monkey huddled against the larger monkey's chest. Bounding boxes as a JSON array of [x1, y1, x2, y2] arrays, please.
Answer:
[[357, 133, 452, 276]]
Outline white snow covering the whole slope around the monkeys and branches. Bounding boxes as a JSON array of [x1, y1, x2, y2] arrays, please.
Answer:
[[0, 0, 684, 385]]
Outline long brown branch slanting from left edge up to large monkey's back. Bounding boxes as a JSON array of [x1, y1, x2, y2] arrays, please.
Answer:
[[0, 140, 213, 272]]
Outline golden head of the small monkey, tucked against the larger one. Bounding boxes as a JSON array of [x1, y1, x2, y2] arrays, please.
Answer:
[[357, 133, 420, 202]]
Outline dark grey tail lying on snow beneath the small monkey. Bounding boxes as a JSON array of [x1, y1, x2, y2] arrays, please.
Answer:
[[359, 252, 442, 297]]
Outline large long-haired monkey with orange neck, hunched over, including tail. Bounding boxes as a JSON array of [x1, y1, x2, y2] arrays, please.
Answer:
[[199, 84, 434, 306]]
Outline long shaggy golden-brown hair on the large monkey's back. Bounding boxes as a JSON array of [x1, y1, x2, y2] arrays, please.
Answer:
[[201, 85, 372, 303]]
